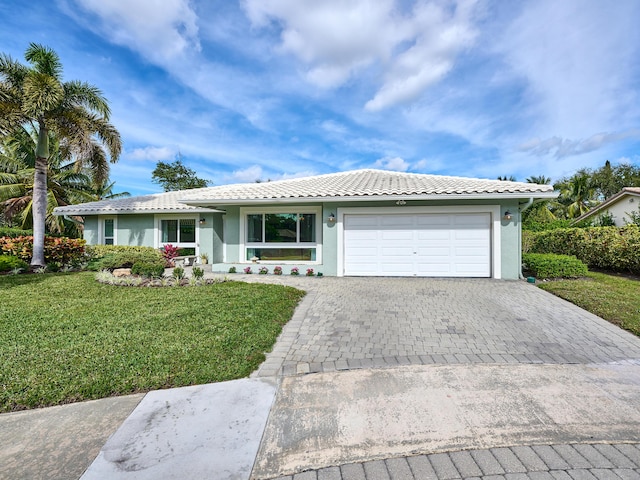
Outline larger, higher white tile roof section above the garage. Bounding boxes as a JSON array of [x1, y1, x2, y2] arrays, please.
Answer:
[[182, 170, 556, 205]]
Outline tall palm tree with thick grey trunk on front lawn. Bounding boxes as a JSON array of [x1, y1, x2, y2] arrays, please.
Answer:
[[0, 43, 122, 266]]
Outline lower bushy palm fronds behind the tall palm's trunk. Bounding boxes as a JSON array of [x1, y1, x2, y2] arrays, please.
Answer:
[[0, 125, 95, 234]]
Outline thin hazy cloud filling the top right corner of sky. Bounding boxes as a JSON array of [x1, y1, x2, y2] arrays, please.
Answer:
[[495, 0, 640, 141]]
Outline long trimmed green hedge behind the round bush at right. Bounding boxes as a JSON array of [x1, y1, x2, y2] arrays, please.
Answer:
[[523, 225, 640, 274]]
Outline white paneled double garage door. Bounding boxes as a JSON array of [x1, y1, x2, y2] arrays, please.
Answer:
[[344, 213, 491, 277]]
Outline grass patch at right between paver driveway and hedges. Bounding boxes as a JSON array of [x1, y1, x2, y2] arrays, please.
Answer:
[[539, 272, 640, 336]]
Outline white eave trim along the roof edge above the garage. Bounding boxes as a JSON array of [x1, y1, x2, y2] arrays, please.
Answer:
[[178, 192, 558, 205]]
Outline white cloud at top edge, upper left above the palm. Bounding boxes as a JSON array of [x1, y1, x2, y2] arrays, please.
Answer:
[[70, 0, 200, 63]]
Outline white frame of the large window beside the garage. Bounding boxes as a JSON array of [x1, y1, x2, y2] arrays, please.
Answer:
[[239, 205, 322, 265]]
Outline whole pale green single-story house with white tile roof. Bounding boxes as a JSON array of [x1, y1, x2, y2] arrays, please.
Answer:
[[55, 170, 557, 279]]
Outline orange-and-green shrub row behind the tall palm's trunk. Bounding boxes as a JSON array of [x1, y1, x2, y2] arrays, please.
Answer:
[[0, 235, 86, 265]]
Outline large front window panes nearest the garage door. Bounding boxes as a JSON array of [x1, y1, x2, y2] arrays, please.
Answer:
[[245, 211, 319, 262]]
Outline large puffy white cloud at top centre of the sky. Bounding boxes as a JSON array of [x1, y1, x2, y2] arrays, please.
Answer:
[[244, 0, 477, 111]]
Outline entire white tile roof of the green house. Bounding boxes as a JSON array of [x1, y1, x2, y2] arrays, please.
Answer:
[[54, 170, 557, 215]]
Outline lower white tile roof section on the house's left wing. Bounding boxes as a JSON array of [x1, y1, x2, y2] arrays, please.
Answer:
[[54, 189, 218, 215]]
